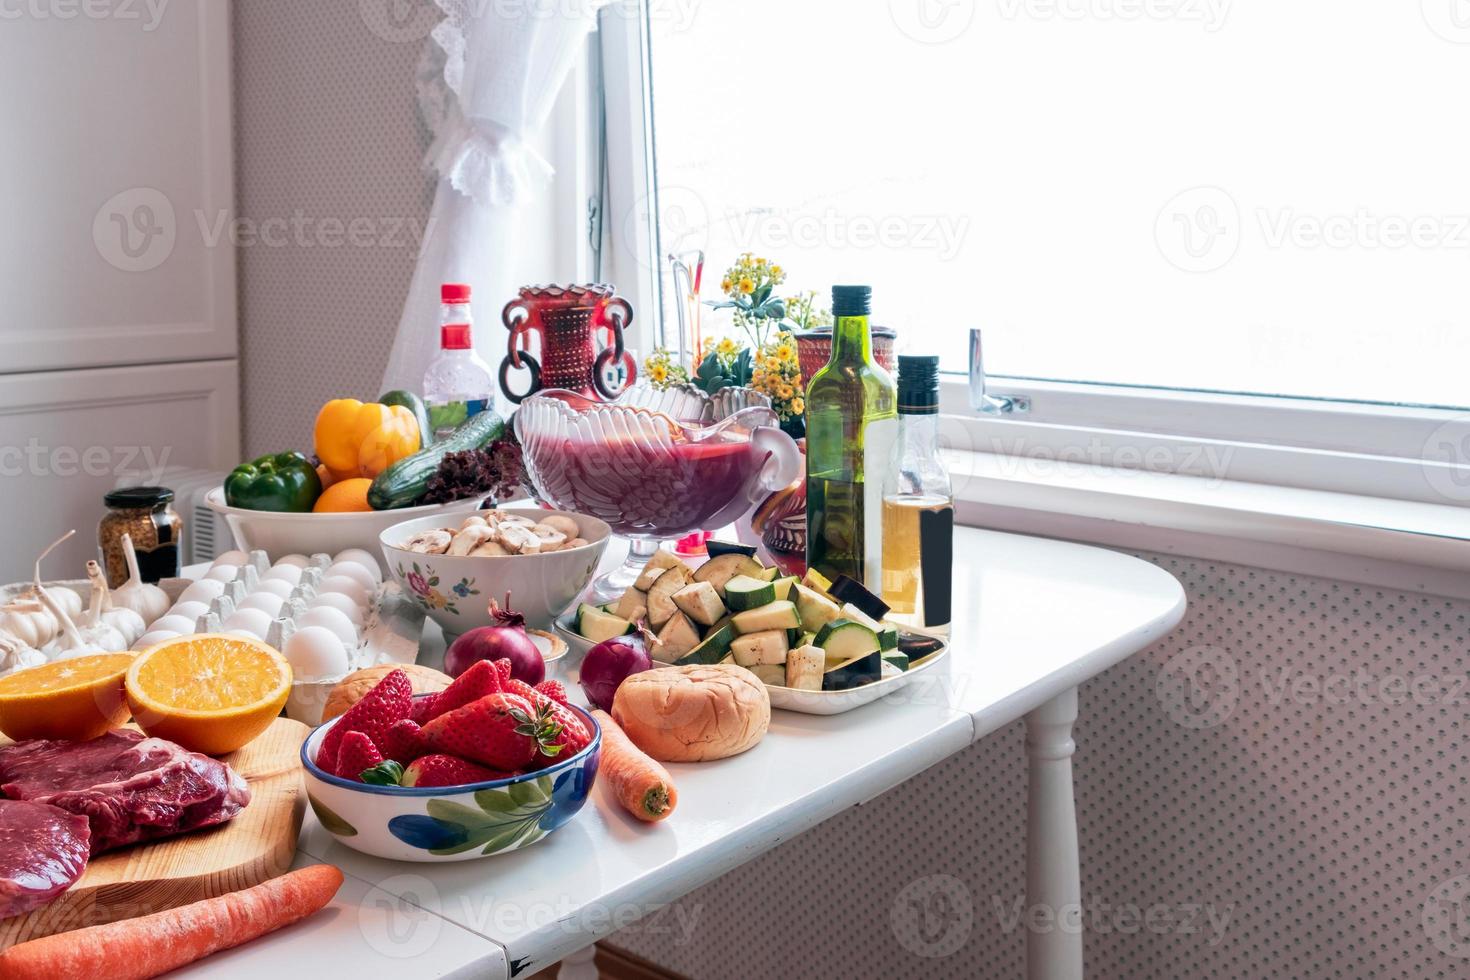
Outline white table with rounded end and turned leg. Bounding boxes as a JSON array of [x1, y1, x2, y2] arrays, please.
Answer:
[[185, 527, 1185, 980]]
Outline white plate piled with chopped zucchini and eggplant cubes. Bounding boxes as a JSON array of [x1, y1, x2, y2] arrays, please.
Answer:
[[557, 541, 948, 714]]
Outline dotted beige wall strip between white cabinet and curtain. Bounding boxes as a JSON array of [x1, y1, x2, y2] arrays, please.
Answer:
[[234, 0, 437, 454]]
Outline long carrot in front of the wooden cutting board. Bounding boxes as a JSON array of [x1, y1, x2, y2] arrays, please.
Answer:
[[0, 864, 343, 980]]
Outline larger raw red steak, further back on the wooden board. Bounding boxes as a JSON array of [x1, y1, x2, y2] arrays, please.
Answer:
[[0, 729, 250, 854]]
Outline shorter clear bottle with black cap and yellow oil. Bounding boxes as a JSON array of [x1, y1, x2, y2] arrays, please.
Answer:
[[882, 354, 954, 635]]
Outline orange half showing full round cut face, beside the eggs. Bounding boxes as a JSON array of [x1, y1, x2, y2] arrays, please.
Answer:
[[125, 633, 291, 755]]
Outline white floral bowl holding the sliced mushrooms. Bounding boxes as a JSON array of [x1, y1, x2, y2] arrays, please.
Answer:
[[378, 507, 612, 636]]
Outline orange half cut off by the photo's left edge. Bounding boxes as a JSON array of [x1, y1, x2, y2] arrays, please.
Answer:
[[0, 654, 134, 742]]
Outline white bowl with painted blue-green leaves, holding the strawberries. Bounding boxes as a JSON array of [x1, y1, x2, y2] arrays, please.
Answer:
[[301, 705, 603, 861]]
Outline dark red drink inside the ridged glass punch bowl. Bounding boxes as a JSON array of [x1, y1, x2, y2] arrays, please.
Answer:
[[526, 432, 767, 538]]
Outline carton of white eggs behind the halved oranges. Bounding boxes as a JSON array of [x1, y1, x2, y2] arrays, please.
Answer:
[[134, 551, 423, 726]]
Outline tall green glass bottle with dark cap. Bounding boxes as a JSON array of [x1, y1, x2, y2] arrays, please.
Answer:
[[807, 287, 898, 592]]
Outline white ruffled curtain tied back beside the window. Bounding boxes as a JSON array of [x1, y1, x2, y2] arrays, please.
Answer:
[[382, 0, 606, 391]]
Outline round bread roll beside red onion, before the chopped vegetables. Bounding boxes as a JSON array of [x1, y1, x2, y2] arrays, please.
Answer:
[[613, 664, 770, 763]]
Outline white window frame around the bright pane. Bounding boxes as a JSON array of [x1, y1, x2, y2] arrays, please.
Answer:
[[582, 0, 1470, 504]]
